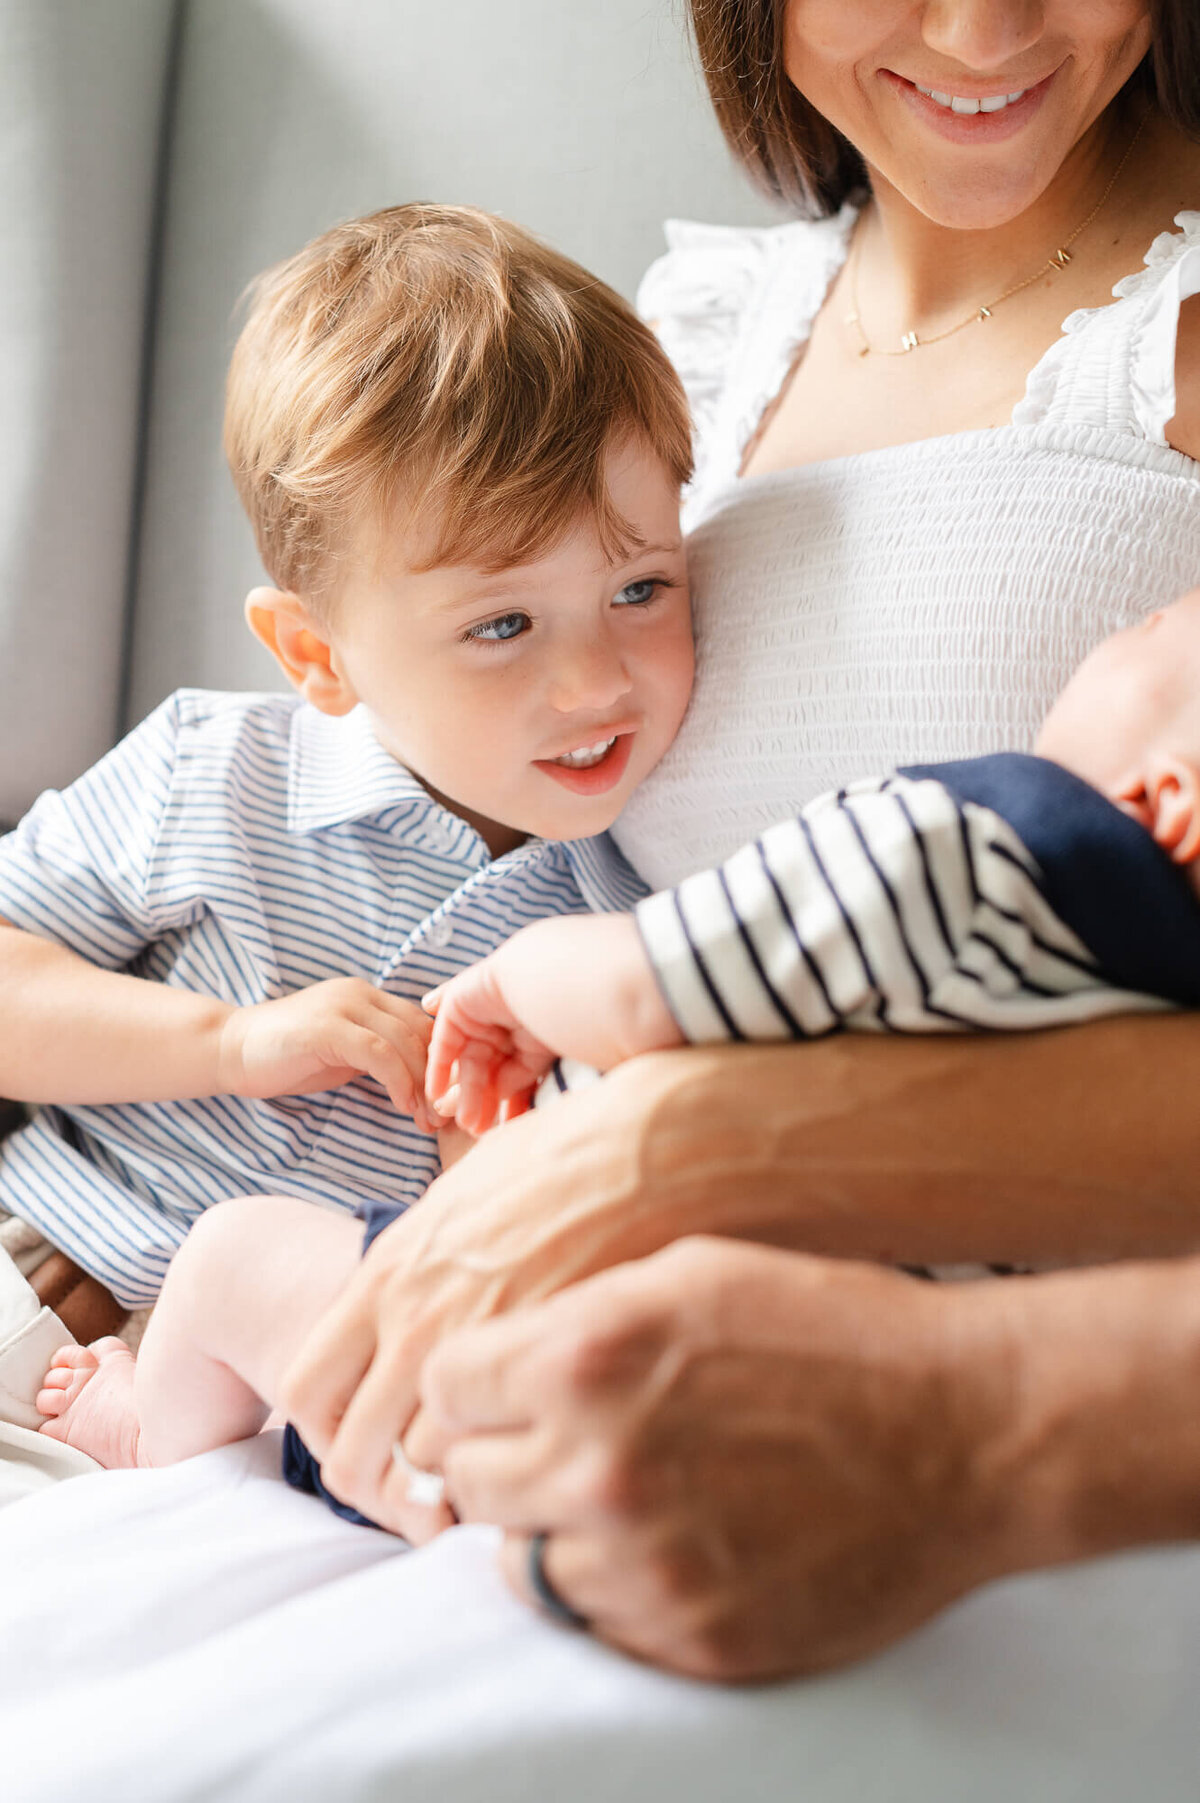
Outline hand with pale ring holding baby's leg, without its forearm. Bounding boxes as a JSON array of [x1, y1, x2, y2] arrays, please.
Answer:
[[279, 1058, 691, 1540]]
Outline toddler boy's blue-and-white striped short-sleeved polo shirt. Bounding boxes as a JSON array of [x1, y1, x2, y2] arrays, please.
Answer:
[[0, 689, 645, 1307]]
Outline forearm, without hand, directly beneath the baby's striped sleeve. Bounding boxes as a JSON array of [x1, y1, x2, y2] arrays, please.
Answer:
[[607, 1015, 1200, 1264]]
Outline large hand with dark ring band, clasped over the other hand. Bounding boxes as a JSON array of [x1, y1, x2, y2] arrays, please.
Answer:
[[405, 1239, 1011, 1679]]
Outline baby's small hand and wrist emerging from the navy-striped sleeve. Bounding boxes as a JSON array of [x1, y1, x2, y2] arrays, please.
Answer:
[[423, 914, 683, 1134]]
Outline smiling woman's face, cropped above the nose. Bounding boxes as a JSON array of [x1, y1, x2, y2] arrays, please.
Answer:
[[784, 0, 1151, 231]]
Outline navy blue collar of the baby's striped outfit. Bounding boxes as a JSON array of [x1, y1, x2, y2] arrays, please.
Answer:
[[899, 752, 1200, 1008]]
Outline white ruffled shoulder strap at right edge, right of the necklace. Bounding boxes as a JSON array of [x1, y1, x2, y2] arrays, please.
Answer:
[[1013, 213, 1200, 445]]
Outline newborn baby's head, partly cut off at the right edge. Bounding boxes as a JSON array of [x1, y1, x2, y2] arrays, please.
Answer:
[[1034, 588, 1200, 864]]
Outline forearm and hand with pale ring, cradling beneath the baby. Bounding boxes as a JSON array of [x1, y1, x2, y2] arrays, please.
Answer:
[[285, 1015, 1200, 1538]]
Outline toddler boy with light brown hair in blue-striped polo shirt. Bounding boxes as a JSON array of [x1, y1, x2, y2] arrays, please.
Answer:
[[11, 206, 692, 1456]]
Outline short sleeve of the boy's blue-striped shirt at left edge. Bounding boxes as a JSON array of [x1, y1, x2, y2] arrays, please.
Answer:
[[0, 696, 180, 970]]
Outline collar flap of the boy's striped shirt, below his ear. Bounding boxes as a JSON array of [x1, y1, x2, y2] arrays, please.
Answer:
[[288, 703, 446, 833]]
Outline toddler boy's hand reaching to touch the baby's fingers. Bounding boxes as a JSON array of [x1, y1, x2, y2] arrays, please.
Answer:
[[218, 977, 445, 1132]]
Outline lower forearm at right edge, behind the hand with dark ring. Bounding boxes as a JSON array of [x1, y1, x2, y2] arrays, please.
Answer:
[[950, 1258, 1200, 1576]]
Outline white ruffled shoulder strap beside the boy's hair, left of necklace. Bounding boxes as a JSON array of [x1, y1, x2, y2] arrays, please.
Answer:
[[638, 207, 856, 492]]
